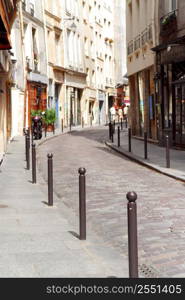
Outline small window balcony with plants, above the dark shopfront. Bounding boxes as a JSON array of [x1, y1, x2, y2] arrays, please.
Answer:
[[160, 10, 177, 38]]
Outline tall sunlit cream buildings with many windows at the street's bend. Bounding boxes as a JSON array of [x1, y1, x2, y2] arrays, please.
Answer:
[[45, 0, 115, 126]]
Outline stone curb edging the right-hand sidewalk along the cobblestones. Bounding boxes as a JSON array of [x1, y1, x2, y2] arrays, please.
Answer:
[[105, 142, 185, 183]]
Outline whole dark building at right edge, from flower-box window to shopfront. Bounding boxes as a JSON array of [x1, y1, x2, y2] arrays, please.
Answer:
[[153, 0, 185, 148]]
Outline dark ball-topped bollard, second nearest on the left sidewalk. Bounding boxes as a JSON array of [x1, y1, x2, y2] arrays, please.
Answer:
[[78, 168, 86, 240]]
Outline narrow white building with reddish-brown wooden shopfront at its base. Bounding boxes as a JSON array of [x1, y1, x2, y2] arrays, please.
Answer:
[[20, 0, 48, 127]]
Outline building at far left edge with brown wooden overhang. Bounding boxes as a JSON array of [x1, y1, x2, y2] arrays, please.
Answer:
[[0, 0, 18, 161]]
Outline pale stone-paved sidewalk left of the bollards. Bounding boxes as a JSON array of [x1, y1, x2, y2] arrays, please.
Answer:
[[0, 137, 128, 278]]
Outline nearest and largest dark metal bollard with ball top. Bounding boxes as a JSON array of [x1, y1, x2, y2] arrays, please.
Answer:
[[127, 192, 138, 278]]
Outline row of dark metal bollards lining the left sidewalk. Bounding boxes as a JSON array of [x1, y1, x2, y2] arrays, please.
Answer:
[[25, 127, 138, 278]]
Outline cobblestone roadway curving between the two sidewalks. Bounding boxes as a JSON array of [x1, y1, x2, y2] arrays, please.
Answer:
[[37, 127, 185, 277]]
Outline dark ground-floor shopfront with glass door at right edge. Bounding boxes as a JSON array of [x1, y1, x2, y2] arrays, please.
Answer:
[[152, 37, 185, 148]]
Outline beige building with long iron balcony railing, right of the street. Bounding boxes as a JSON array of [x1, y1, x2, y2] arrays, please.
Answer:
[[126, 0, 157, 140]]
